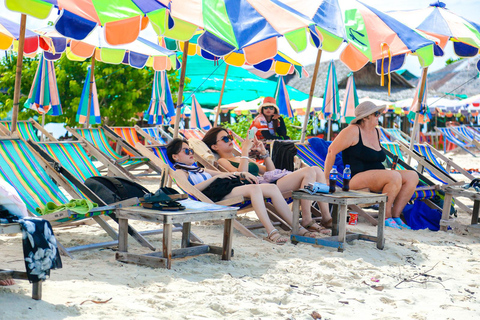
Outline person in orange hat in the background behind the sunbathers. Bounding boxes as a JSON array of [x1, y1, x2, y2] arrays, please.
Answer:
[[250, 97, 290, 140]]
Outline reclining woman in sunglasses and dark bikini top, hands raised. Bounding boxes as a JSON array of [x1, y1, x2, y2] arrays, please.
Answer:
[[203, 127, 332, 233]]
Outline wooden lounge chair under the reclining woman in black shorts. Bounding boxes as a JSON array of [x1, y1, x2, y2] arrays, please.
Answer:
[[136, 144, 291, 238]]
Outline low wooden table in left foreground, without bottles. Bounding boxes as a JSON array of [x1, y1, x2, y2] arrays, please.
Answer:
[[115, 200, 238, 269]]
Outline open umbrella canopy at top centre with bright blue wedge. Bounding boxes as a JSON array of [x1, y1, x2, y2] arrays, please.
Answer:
[[164, 0, 313, 65]]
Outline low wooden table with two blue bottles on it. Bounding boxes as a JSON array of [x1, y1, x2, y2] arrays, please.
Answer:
[[291, 191, 387, 252]]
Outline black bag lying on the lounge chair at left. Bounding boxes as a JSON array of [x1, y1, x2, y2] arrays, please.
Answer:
[[85, 176, 149, 204]]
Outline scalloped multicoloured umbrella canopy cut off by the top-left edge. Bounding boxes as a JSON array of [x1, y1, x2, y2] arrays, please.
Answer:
[[5, 0, 172, 45]]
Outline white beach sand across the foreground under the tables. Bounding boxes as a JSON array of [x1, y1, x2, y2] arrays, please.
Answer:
[[0, 155, 480, 319]]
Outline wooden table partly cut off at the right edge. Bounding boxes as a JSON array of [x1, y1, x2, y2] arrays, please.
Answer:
[[440, 187, 480, 231]]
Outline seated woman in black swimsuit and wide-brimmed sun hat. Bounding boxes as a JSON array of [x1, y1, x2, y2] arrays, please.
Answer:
[[325, 101, 418, 229]]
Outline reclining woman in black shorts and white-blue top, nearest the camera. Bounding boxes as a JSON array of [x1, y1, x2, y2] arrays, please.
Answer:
[[167, 138, 317, 244]]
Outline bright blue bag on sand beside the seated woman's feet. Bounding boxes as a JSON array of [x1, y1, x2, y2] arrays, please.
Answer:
[[403, 200, 442, 231]]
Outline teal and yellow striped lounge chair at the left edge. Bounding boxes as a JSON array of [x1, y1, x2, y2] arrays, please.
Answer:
[[0, 138, 155, 256]]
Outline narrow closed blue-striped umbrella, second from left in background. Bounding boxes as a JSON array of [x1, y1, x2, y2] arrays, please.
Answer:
[[76, 66, 102, 124]]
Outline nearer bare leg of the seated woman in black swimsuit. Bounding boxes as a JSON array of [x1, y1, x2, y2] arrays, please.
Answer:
[[350, 170, 402, 218]]
